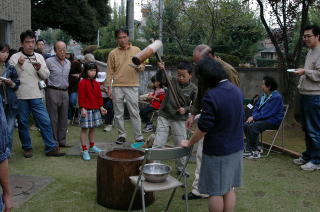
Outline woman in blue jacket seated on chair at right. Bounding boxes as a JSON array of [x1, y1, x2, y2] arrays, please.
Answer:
[[244, 76, 284, 158]]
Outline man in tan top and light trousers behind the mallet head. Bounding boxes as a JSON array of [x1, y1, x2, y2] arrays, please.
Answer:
[[106, 29, 144, 144]]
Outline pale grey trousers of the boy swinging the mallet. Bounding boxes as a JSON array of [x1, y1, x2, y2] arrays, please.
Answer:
[[152, 116, 187, 171]]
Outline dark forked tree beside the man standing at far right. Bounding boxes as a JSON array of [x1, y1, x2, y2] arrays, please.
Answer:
[[256, 0, 315, 123]]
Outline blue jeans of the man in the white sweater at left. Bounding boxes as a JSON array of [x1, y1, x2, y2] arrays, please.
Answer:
[[18, 98, 57, 152]]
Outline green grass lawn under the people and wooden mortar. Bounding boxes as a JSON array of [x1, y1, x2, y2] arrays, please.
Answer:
[[9, 122, 320, 212]]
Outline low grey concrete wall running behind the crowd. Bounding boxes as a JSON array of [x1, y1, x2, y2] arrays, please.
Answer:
[[97, 61, 284, 98]]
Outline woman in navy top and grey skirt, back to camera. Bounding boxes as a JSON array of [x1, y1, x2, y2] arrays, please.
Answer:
[[181, 58, 244, 212]]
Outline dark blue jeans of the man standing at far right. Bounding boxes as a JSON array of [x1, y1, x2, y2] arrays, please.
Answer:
[[300, 95, 320, 164]]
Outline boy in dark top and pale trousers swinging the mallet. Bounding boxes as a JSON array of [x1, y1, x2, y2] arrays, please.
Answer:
[[153, 62, 198, 174]]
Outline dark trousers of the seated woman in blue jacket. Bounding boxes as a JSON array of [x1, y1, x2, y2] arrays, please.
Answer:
[[244, 121, 279, 151]]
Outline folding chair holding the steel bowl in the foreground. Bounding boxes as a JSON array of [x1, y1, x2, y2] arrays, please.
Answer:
[[128, 147, 192, 212]]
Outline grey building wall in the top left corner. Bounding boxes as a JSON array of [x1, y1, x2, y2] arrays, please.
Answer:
[[0, 0, 31, 49]]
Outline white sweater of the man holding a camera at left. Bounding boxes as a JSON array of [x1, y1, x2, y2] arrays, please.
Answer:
[[9, 52, 50, 99]]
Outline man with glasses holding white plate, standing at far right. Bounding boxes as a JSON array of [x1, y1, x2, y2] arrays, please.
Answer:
[[293, 25, 320, 171]]
